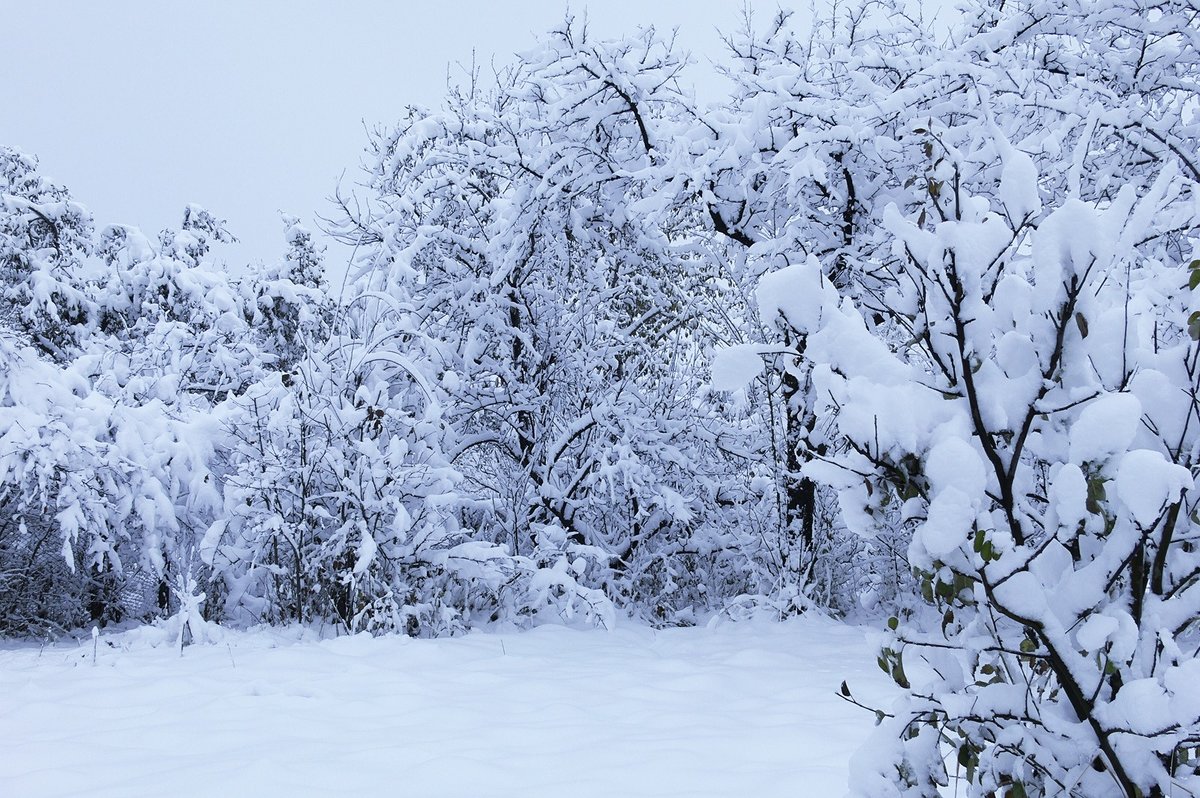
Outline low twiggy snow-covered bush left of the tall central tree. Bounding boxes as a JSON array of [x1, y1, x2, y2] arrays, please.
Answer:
[[211, 328, 455, 630]]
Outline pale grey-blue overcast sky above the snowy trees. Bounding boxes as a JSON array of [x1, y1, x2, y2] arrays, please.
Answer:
[[0, 0, 758, 271]]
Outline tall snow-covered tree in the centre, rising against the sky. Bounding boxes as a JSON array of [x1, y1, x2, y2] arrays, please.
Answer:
[[328, 17, 787, 620]]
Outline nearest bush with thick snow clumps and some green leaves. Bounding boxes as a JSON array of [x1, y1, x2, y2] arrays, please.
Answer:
[[792, 79, 1200, 797]]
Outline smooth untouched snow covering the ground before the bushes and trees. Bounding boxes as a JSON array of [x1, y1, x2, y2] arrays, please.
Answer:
[[0, 619, 888, 798]]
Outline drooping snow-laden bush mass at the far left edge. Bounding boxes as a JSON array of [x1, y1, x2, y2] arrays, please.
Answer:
[[0, 149, 272, 632]]
